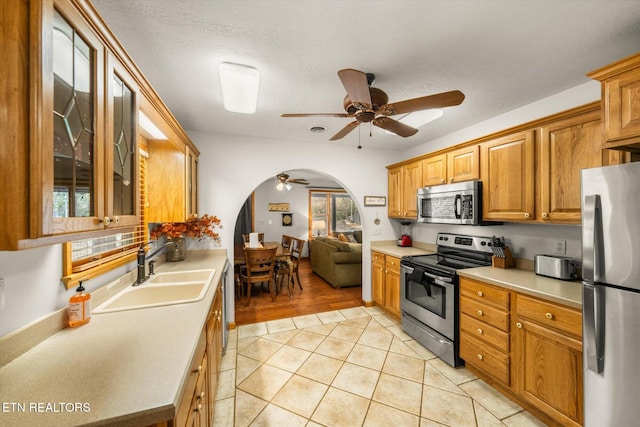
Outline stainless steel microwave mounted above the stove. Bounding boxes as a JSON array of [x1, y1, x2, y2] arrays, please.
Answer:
[[418, 180, 482, 225]]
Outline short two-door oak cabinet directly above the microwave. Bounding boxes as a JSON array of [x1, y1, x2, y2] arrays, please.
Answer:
[[422, 145, 480, 187]]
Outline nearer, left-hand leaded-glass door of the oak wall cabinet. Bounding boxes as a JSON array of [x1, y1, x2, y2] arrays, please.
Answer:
[[46, 3, 104, 235]]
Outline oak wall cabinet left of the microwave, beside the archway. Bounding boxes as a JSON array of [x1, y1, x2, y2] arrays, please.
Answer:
[[388, 161, 422, 219]]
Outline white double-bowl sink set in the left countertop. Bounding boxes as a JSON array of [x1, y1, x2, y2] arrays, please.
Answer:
[[92, 270, 215, 314]]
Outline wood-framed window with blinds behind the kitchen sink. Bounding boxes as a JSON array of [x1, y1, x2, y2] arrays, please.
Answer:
[[60, 151, 148, 289]]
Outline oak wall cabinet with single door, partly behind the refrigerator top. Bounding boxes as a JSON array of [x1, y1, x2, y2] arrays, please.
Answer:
[[536, 106, 621, 223]]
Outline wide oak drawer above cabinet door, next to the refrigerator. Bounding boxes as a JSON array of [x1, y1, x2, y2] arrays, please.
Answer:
[[516, 295, 582, 337]]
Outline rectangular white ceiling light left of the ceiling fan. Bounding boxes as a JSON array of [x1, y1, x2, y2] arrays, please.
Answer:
[[218, 62, 260, 114]]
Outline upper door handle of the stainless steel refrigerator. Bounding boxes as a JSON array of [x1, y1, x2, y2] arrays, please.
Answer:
[[582, 194, 603, 283]]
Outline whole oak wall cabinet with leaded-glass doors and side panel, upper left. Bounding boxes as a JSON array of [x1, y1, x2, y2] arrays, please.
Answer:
[[0, 0, 197, 250]]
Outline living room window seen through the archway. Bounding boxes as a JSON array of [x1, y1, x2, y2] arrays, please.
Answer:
[[309, 190, 362, 236]]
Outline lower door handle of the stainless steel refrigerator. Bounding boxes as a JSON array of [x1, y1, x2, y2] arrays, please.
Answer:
[[582, 282, 605, 374]]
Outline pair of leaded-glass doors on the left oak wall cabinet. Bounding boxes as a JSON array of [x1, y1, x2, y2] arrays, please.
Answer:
[[36, 0, 139, 237]]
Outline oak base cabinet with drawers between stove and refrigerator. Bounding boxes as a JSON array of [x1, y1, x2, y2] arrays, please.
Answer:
[[460, 277, 583, 426]]
